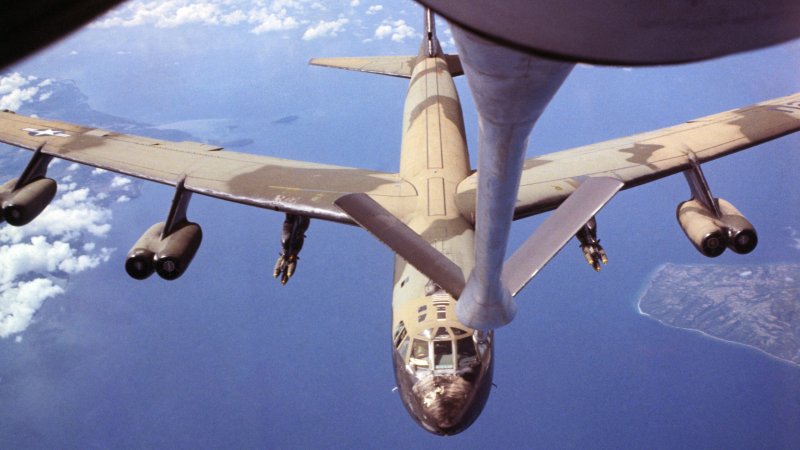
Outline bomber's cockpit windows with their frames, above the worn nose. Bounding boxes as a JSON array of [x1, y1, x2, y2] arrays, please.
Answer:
[[394, 322, 487, 373]]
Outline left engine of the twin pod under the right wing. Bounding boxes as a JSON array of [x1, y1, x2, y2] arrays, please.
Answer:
[[677, 199, 727, 258]]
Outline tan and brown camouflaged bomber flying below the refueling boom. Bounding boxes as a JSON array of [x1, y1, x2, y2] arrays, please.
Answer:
[[0, 12, 800, 435]]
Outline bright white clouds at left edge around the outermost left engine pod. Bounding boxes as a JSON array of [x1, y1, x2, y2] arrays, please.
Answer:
[[0, 73, 137, 338]]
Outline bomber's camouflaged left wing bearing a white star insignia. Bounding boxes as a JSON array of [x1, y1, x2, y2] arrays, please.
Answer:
[[0, 112, 416, 224]]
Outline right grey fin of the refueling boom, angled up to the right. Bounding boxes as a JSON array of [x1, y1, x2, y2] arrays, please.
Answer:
[[502, 177, 624, 296]]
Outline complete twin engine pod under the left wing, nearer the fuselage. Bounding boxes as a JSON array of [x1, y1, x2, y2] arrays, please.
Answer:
[[125, 221, 203, 280]]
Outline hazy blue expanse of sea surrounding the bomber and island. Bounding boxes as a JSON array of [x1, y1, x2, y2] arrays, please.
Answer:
[[0, 1, 800, 448]]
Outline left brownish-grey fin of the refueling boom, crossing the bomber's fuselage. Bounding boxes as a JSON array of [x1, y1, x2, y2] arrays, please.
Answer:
[[334, 194, 465, 298]]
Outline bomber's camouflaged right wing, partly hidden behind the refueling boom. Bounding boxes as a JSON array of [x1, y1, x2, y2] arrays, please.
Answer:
[[457, 93, 800, 219]]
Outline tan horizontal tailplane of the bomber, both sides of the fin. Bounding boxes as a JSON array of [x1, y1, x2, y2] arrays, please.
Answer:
[[308, 55, 464, 78]]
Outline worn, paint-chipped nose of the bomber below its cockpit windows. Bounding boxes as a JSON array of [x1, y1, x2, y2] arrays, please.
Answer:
[[413, 375, 480, 435]]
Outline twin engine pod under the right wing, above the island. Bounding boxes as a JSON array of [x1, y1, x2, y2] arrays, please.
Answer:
[[677, 198, 758, 258]]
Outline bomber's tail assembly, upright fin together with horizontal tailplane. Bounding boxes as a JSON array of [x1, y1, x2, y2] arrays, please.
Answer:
[[309, 8, 464, 78]]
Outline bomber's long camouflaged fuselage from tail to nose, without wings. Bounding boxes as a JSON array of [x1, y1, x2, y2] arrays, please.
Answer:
[[392, 45, 493, 434]]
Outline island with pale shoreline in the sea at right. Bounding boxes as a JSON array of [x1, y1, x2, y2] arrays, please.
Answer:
[[638, 264, 800, 365]]
